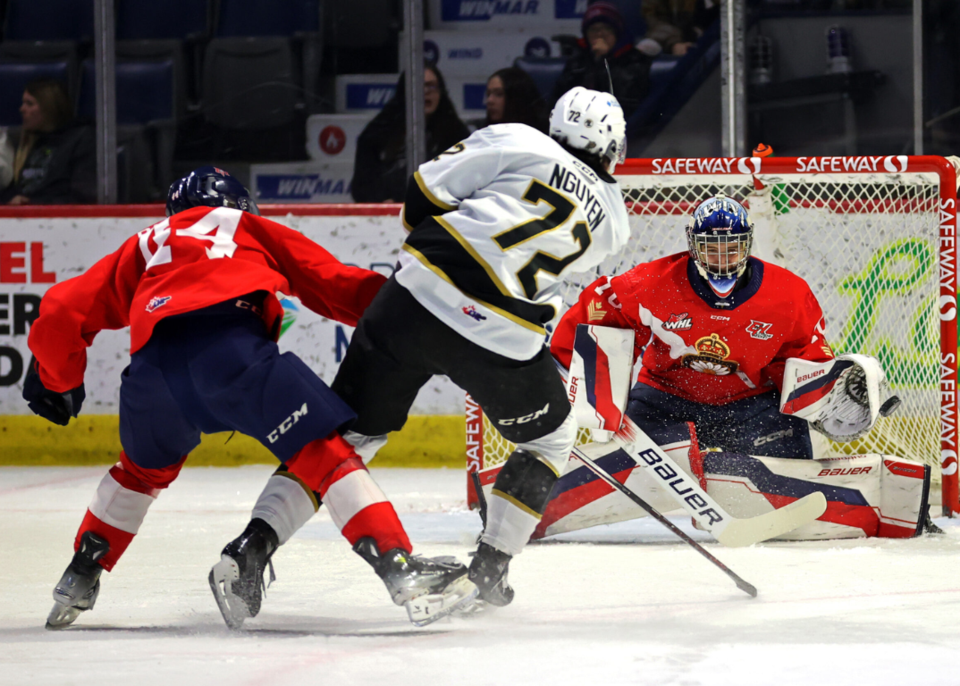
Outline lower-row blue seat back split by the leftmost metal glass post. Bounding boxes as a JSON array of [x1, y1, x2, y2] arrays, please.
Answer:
[[77, 59, 176, 124]]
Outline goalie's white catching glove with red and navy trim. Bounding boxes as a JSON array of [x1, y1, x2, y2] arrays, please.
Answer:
[[780, 354, 900, 443]]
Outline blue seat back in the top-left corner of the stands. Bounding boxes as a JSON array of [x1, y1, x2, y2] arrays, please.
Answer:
[[3, 0, 93, 40]]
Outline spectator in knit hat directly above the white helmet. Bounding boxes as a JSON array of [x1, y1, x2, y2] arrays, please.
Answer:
[[553, 2, 650, 119]]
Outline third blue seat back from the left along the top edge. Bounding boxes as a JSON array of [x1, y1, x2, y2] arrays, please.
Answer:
[[215, 0, 320, 38]]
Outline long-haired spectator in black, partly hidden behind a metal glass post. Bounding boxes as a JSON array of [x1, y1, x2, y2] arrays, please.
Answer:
[[350, 62, 470, 202]]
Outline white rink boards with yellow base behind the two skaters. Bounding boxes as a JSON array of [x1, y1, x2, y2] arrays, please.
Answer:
[[0, 205, 465, 466]]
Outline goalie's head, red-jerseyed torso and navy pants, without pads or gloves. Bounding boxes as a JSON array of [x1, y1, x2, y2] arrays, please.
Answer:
[[551, 196, 833, 458]]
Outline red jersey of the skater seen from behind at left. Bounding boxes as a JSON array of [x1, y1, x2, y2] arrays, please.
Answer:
[[28, 207, 386, 392]]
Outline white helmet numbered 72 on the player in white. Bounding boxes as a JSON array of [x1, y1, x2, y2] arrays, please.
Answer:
[[550, 86, 627, 174]]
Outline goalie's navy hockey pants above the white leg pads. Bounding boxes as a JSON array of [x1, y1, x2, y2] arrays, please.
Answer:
[[627, 383, 813, 459]]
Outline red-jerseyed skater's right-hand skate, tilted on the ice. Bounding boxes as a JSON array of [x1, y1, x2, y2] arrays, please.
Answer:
[[353, 537, 478, 626]]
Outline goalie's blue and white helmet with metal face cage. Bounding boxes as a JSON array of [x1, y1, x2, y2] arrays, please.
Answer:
[[687, 194, 753, 278]]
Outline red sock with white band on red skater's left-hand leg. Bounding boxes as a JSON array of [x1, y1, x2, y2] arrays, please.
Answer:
[[73, 451, 187, 572]]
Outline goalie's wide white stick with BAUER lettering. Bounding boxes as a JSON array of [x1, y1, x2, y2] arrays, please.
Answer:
[[616, 417, 827, 548]]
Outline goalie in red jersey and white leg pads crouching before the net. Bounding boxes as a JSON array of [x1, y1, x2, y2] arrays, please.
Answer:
[[535, 196, 936, 540]]
